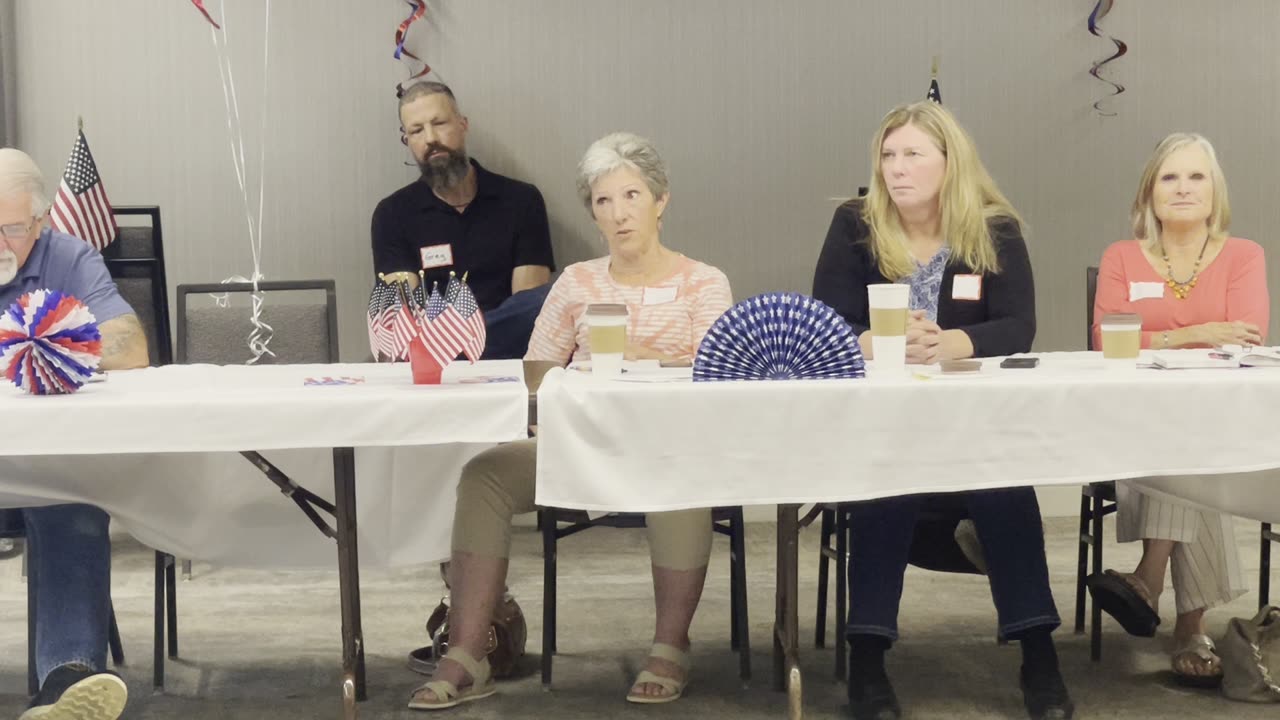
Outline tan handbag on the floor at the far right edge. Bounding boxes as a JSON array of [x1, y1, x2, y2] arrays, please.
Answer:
[[1217, 605, 1280, 702]]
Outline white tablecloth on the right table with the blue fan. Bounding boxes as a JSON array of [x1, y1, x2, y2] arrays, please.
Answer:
[[538, 352, 1280, 521]]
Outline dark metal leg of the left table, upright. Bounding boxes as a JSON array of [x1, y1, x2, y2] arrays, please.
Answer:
[[333, 447, 366, 702]]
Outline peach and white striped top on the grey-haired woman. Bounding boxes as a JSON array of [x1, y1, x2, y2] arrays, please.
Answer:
[[525, 255, 733, 365]]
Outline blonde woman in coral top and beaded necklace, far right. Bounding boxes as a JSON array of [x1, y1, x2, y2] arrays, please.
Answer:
[[1089, 133, 1270, 687]]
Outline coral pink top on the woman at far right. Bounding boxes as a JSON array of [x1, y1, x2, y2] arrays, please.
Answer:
[[1093, 237, 1271, 347]]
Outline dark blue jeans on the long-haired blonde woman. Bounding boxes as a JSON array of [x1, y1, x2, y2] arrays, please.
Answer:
[[846, 488, 1061, 641]]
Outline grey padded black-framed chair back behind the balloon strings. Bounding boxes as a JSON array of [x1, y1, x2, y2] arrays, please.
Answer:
[[175, 279, 338, 365]]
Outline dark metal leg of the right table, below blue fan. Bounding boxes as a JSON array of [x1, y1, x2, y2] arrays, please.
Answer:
[[773, 505, 804, 720]]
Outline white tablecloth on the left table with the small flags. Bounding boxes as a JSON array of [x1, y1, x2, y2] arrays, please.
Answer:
[[0, 361, 527, 566]]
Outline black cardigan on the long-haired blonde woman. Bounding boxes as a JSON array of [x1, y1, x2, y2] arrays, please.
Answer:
[[813, 200, 1036, 357]]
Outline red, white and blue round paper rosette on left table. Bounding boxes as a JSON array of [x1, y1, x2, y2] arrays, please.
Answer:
[[0, 290, 102, 395]]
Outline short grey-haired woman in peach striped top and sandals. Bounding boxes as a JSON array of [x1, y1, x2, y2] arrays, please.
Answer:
[[410, 133, 732, 710]]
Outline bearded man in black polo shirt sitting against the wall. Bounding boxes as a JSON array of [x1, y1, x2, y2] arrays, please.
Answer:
[[372, 82, 556, 357]]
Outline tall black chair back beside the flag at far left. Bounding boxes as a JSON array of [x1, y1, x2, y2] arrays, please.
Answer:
[[102, 205, 173, 365]]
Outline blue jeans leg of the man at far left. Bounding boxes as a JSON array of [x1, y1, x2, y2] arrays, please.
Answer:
[[22, 505, 111, 685]]
